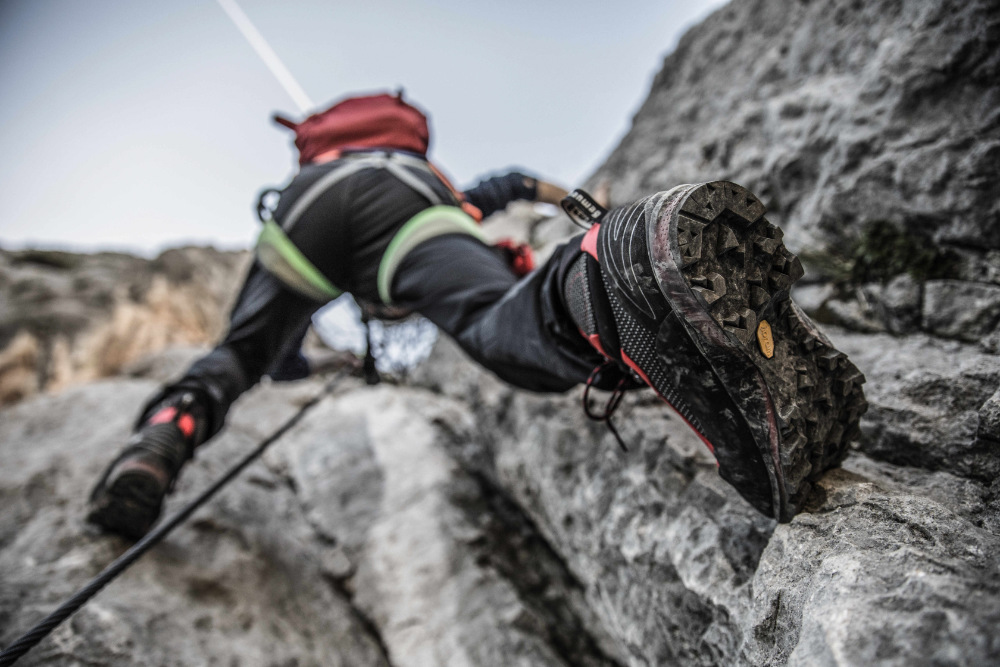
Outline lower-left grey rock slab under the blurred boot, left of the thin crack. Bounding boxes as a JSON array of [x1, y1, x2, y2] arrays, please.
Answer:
[[0, 380, 388, 666]]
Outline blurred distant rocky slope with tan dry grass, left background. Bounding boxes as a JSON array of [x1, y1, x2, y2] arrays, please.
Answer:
[[0, 247, 250, 405]]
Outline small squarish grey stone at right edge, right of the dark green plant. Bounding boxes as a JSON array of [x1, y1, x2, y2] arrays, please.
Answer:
[[923, 280, 1000, 342]]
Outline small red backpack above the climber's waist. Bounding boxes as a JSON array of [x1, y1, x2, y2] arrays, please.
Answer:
[[274, 92, 430, 165]]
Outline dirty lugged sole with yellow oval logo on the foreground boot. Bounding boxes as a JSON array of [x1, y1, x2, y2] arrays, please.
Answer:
[[645, 181, 867, 521]]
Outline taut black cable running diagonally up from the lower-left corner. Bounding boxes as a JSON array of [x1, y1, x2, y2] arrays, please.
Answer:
[[0, 377, 340, 667]]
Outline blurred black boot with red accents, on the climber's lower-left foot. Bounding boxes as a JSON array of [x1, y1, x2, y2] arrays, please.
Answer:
[[87, 393, 206, 539]]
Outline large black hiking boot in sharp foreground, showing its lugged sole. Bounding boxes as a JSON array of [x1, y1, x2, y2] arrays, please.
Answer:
[[566, 181, 867, 521]]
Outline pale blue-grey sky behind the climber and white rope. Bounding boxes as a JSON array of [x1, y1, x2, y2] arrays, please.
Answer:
[[0, 0, 724, 253]]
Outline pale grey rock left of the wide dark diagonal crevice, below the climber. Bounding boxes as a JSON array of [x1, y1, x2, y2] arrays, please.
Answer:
[[0, 370, 622, 667]]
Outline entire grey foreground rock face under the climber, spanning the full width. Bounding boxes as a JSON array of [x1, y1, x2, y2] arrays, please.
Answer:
[[0, 322, 1000, 665]]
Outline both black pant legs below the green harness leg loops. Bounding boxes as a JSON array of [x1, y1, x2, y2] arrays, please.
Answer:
[[144, 234, 602, 435]]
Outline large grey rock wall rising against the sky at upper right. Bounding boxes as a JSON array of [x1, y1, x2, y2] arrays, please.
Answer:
[[590, 0, 1000, 252]]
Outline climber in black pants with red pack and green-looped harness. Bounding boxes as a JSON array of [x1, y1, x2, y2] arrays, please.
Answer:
[[88, 94, 866, 538]]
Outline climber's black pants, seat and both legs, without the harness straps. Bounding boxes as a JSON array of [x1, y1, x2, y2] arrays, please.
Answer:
[[140, 161, 602, 435]]
